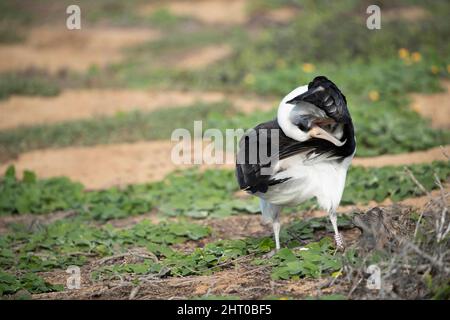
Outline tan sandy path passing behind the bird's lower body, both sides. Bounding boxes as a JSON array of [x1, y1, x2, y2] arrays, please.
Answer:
[[0, 141, 450, 189]]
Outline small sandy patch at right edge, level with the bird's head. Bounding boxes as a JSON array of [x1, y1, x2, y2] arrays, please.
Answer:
[[411, 81, 450, 129]]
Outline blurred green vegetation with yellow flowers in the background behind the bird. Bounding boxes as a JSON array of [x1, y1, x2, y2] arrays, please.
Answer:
[[0, 0, 450, 156]]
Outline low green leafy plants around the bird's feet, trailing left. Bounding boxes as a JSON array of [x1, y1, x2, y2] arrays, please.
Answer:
[[93, 218, 349, 279]]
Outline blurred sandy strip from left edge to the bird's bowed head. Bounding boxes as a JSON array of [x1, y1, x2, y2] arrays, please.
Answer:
[[0, 89, 276, 130]]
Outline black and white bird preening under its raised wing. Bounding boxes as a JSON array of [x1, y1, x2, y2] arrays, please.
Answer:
[[236, 76, 356, 250]]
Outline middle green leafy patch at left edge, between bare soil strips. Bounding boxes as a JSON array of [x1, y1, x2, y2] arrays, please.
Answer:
[[0, 220, 210, 272]]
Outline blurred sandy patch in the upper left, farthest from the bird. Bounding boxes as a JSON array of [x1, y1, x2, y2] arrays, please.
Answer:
[[0, 26, 159, 72]]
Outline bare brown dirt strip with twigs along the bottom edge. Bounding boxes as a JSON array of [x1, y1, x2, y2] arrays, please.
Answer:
[[33, 259, 337, 300]]
